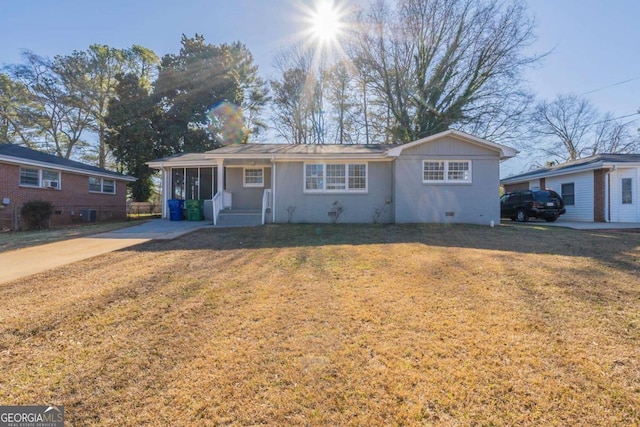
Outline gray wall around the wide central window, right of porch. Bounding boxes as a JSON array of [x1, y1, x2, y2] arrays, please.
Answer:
[[274, 162, 394, 223]]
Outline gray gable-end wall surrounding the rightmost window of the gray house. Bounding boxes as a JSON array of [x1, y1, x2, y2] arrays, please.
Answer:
[[394, 138, 500, 225]]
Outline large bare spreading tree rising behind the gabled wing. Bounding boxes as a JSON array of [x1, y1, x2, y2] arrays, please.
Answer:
[[350, 0, 539, 142]]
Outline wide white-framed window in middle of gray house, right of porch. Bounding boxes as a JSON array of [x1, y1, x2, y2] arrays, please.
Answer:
[[304, 163, 367, 192]]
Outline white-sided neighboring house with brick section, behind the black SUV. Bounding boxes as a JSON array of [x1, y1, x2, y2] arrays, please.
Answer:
[[500, 154, 640, 226]]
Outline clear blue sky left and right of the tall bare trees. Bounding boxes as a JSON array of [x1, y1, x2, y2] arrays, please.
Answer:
[[0, 0, 640, 173]]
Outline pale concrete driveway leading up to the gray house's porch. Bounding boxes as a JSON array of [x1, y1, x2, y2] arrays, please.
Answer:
[[0, 219, 213, 284]]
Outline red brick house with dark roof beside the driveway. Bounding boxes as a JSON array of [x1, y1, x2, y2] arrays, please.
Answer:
[[0, 144, 135, 229]]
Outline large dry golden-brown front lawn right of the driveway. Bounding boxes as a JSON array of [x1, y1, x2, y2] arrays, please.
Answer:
[[0, 225, 640, 426]]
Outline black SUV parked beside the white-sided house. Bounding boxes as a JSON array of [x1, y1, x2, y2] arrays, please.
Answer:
[[500, 190, 567, 222]]
